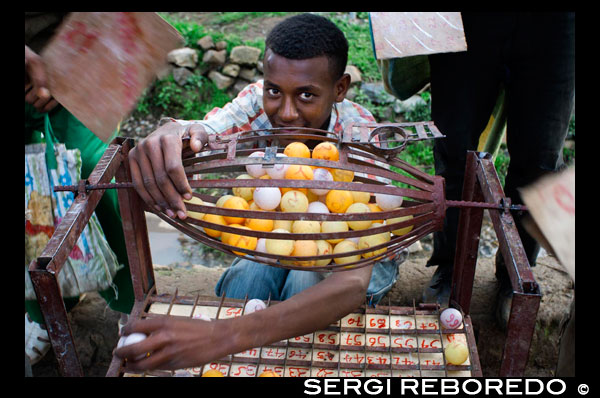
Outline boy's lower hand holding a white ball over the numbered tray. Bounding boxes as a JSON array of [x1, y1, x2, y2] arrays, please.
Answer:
[[114, 316, 233, 371]]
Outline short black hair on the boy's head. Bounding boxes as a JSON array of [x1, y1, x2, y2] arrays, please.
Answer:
[[265, 13, 348, 80]]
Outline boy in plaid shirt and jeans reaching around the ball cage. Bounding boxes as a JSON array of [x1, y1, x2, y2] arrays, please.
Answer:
[[115, 14, 403, 370]]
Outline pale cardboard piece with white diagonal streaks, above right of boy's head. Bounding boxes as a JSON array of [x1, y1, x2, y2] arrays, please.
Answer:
[[370, 12, 467, 59]]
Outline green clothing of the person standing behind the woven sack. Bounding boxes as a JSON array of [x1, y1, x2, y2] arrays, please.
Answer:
[[25, 103, 134, 323]]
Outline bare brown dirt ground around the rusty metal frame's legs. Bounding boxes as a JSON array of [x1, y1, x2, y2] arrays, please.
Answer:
[[33, 213, 574, 377]]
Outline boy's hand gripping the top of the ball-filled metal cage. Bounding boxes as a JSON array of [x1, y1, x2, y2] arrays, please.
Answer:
[[129, 122, 208, 220]]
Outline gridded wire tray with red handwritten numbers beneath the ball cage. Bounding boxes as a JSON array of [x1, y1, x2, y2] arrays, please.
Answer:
[[107, 291, 481, 377]]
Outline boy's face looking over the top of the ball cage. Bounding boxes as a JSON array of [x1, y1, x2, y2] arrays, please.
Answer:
[[263, 49, 350, 132]]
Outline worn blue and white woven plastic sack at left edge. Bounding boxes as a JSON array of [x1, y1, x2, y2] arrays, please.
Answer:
[[25, 115, 123, 300]]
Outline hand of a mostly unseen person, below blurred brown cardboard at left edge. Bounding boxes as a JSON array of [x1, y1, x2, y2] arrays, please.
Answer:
[[25, 46, 58, 113]]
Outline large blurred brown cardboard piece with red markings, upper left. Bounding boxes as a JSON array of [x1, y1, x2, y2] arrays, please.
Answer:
[[41, 12, 183, 142]]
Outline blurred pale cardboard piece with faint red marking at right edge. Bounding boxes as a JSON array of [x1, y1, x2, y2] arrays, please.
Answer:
[[521, 166, 575, 281]]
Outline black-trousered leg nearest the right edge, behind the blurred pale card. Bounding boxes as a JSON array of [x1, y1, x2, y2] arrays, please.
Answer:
[[496, 13, 575, 325]]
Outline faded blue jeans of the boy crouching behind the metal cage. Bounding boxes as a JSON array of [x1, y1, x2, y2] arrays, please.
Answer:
[[215, 250, 408, 304]]
